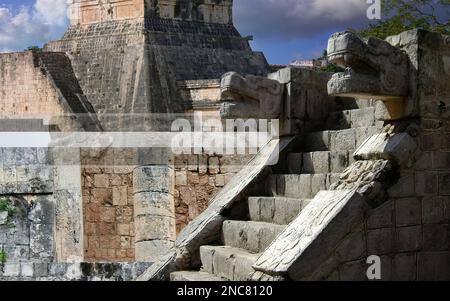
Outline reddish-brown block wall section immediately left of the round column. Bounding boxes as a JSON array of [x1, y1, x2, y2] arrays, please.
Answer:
[[82, 149, 135, 262]]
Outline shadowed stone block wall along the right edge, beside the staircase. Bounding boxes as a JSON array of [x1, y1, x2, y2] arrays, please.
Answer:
[[333, 30, 450, 280]]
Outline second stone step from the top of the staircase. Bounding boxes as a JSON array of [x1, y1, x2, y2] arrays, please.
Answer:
[[303, 126, 381, 152]]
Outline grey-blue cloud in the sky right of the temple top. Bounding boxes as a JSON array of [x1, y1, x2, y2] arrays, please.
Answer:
[[234, 0, 369, 40]]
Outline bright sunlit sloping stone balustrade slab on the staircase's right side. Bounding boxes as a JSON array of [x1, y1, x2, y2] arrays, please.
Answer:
[[254, 190, 368, 280]]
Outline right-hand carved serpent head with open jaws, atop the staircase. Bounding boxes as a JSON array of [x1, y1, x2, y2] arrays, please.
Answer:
[[328, 31, 409, 100]]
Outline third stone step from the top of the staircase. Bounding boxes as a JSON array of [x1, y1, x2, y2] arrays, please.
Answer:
[[287, 151, 354, 174]]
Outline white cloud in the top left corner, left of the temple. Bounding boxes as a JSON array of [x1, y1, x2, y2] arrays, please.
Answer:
[[0, 0, 67, 52]]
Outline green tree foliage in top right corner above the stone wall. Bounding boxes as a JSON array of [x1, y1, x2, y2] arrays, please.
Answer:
[[359, 0, 450, 39]]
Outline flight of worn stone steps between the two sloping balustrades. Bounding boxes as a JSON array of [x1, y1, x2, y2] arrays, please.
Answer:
[[171, 102, 382, 281]]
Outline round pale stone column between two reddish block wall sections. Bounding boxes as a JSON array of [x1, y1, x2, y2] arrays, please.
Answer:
[[133, 164, 176, 262]]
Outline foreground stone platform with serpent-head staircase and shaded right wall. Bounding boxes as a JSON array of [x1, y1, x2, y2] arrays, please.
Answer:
[[139, 30, 450, 281]]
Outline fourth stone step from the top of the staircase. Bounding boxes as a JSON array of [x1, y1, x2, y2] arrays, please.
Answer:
[[267, 173, 340, 199]]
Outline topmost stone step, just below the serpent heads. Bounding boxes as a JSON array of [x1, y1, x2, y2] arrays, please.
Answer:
[[325, 107, 376, 130]]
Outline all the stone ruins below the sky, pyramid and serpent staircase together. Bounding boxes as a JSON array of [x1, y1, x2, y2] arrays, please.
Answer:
[[0, 0, 450, 281]]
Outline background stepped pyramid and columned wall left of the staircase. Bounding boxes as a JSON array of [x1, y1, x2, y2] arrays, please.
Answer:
[[0, 0, 267, 280]]
